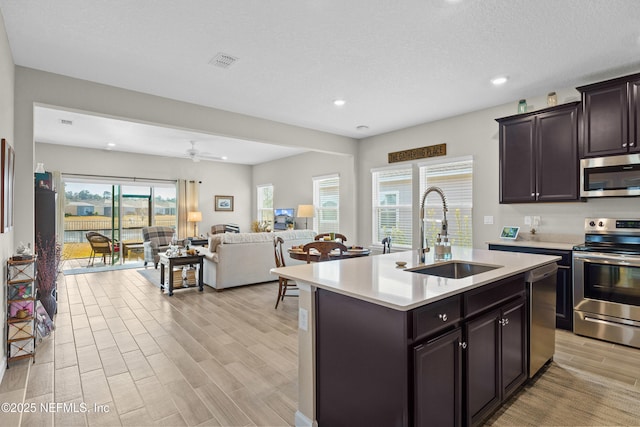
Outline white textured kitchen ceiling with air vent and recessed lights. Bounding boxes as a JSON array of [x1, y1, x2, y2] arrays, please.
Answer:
[[0, 0, 640, 160]]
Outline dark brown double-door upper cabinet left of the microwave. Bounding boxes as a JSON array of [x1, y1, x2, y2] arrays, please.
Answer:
[[496, 102, 580, 203]]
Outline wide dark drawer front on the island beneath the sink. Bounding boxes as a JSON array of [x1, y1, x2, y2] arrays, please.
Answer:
[[464, 274, 525, 317]]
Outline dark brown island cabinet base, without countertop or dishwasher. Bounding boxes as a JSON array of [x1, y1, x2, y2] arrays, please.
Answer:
[[316, 275, 528, 426]]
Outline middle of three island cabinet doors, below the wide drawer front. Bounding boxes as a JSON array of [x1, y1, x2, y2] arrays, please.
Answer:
[[464, 309, 501, 426]]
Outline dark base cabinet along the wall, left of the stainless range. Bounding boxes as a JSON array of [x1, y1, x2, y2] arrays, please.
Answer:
[[489, 244, 573, 331]]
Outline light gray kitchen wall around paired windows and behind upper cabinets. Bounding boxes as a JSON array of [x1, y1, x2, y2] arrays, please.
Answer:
[[358, 88, 640, 248]]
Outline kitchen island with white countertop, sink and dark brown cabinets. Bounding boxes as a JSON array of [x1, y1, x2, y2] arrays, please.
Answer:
[[272, 248, 559, 426]]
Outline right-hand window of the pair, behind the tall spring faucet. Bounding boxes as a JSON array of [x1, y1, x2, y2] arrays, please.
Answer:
[[420, 158, 473, 247]]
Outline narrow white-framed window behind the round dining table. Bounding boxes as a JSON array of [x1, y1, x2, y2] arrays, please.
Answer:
[[313, 175, 340, 233]]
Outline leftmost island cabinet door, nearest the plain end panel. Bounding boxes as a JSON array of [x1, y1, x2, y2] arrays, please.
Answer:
[[413, 328, 462, 427]]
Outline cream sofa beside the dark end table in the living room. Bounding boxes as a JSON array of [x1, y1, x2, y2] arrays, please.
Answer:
[[199, 230, 316, 290]]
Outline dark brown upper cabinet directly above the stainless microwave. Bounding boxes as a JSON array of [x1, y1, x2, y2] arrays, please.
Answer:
[[577, 74, 640, 157]]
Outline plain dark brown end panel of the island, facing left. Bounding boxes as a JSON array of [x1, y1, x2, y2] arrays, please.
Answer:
[[316, 289, 411, 427]]
